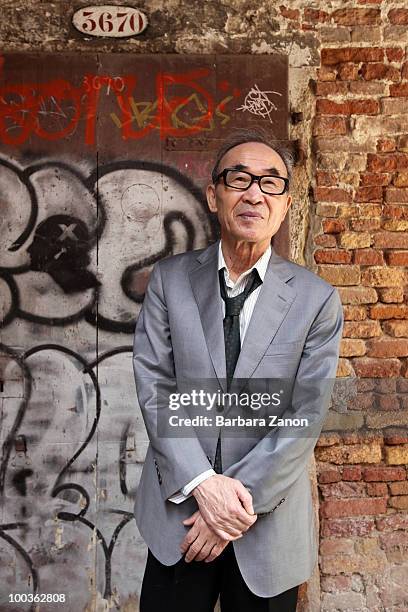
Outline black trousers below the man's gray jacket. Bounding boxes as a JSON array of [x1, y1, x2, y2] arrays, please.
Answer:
[[140, 543, 299, 612]]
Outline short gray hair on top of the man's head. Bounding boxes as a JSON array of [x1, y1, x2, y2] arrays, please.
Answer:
[[211, 128, 295, 183]]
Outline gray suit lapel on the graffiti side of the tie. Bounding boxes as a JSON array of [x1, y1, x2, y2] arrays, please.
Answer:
[[190, 242, 227, 391]]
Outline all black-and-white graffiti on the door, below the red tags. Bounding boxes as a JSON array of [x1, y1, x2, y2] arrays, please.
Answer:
[[0, 149, 215, 612]]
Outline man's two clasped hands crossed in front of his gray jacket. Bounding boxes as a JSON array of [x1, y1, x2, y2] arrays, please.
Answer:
[[180, 474, 257, 563]]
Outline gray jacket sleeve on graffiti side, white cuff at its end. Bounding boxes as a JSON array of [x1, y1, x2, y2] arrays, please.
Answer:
[[133, 263, 211, 500]]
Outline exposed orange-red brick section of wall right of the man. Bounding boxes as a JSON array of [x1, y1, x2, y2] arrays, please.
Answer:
[[304, 2, 408, 610]]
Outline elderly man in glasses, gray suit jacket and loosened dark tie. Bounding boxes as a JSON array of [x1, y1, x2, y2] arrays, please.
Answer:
[[134, 132, 343, 612]]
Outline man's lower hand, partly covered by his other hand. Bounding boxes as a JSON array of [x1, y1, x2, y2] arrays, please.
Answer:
[[180, 510, 228, 563]]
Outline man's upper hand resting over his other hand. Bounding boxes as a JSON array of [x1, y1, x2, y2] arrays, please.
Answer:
[[192, 474, 257, 541]]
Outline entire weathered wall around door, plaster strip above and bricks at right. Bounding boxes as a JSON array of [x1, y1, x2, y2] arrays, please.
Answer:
[[0, 0, 408, 612]]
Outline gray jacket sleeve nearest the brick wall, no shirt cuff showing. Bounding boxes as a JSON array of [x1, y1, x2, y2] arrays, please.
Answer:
[[224, 289, 343, 514]]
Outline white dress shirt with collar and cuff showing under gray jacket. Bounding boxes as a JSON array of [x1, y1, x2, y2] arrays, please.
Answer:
[[169, 241, 272, 504]]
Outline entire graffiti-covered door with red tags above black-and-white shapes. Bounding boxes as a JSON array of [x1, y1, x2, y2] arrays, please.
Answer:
[[0, 53, 287, 612]]
